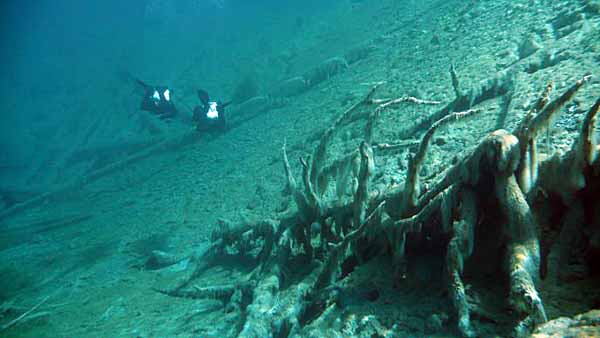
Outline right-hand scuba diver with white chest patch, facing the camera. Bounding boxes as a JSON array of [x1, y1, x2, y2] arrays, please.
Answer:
[[192, 89, 231, 131]]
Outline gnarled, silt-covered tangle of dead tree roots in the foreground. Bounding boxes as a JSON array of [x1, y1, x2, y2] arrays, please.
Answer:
[[159, 69, 600, 337]]
